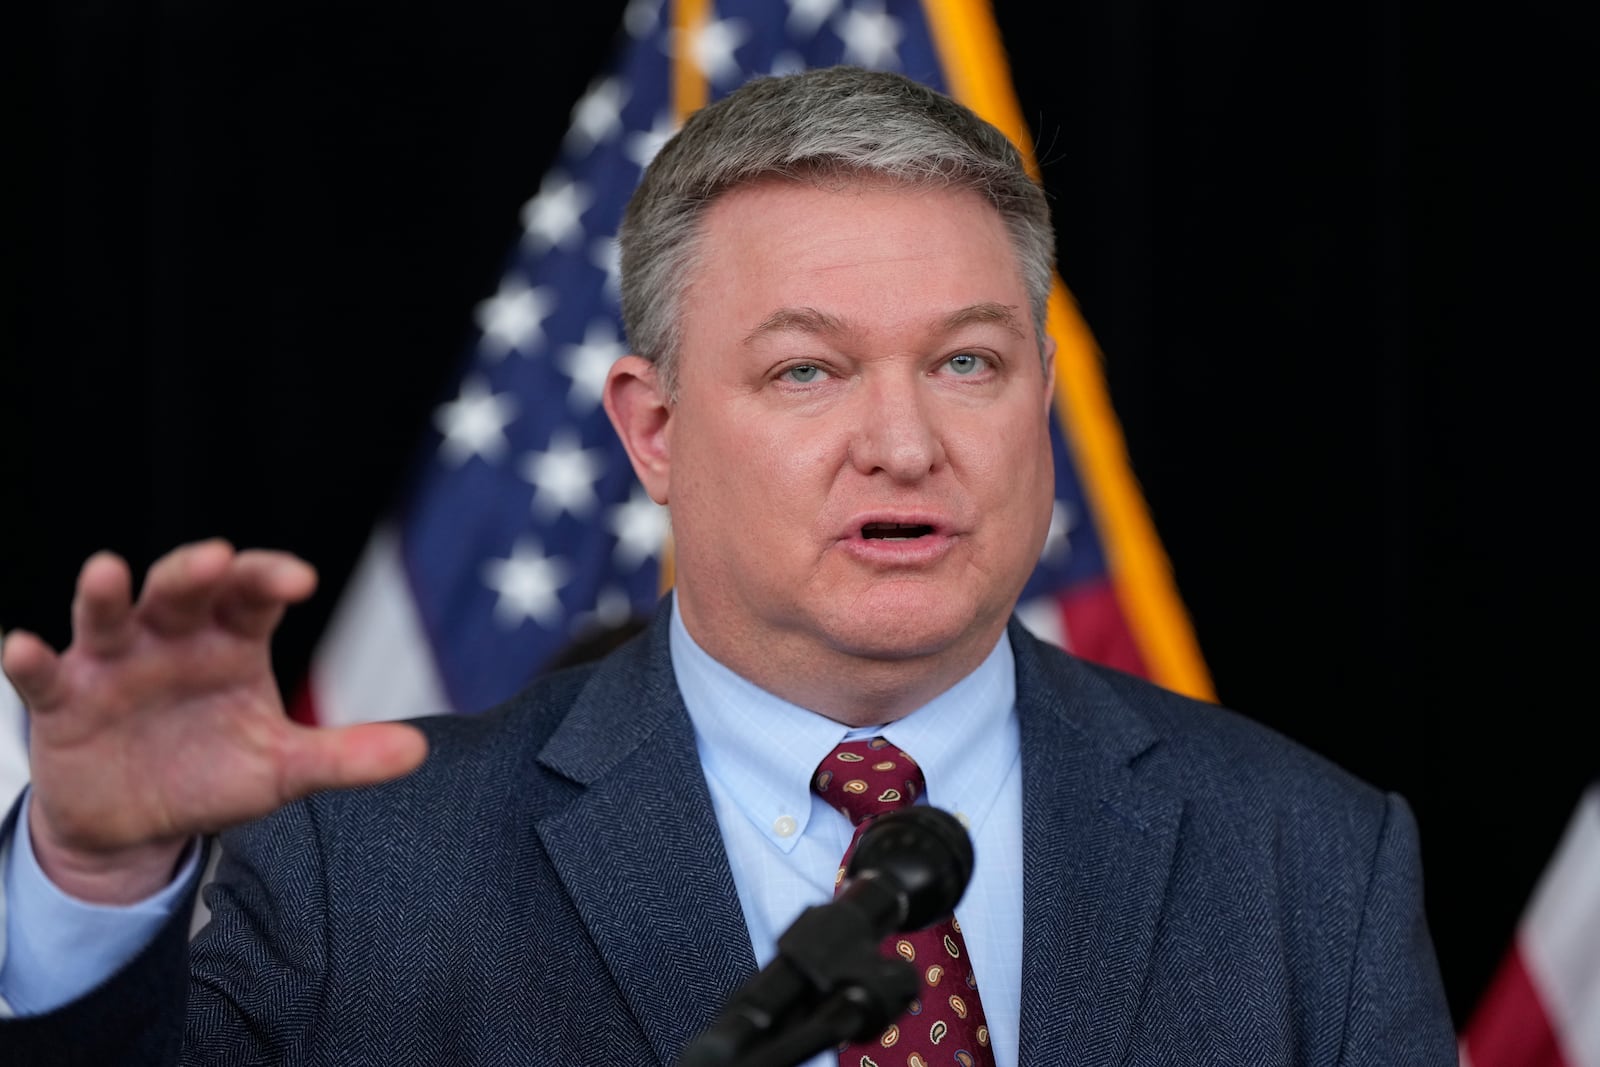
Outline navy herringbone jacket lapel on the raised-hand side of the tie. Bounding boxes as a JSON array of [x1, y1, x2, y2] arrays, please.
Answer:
[[538, 613, 755, 1064]]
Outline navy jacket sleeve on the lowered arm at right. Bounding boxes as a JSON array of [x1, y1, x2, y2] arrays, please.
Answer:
[[1339, 795, 1458, 1067]]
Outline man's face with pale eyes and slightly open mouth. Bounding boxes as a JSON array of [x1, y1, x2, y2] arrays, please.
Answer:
[[617, 173, 1054, 702]]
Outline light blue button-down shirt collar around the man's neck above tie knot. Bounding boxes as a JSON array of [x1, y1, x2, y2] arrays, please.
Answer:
[[670, 598, 1021, 851]]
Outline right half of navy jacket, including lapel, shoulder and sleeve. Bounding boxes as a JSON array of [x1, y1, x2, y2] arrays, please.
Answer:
[[1011, 625, 1454, 1067]]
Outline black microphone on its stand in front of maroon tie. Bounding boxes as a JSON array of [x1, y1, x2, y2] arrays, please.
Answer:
[[678, 806, 973, 1067]]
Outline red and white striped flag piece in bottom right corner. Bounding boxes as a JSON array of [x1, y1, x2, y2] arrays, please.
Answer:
[[1461, 785, 1600, 1067]]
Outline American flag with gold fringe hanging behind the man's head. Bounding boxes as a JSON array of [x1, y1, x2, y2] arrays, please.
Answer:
[[296, 0, 1210, 725]]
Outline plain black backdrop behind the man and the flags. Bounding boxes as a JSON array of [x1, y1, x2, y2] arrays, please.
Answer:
[[0, 0, 1600, 1021]]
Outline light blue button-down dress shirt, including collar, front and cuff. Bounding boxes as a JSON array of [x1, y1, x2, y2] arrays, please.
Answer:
[[0, 603, 1022, 1067]]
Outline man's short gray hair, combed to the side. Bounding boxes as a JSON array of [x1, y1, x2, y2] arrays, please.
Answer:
[[618, 67, 1056, 397]]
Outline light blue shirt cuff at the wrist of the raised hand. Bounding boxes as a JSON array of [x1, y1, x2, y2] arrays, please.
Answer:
[[0, 795, 200, 1016]]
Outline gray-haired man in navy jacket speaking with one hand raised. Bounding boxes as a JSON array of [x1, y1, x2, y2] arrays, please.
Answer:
[[0, 69, 1454, 1067]]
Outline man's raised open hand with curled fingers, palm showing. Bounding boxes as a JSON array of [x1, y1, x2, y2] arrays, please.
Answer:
[[0, 541, 427, 904]]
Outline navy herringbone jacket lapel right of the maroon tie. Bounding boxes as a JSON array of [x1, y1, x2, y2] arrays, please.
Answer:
[[1011, 625, 1182, 1067]]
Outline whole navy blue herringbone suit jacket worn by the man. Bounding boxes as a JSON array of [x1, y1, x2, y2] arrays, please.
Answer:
[[0, 613, 1456, 1067]]
